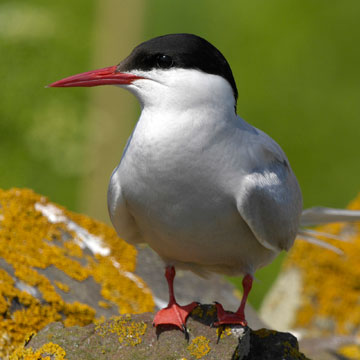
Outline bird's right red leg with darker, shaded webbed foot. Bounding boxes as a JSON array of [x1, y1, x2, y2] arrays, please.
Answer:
[[214, 274, 253, 326]]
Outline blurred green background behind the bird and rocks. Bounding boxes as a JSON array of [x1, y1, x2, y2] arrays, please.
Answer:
[[0, 0, 360, 306]]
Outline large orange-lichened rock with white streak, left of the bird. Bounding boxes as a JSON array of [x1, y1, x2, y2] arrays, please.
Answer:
[[0, 189, 154, 359]]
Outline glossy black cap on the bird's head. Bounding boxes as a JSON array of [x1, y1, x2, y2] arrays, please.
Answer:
[[117, 34, 238, 101]]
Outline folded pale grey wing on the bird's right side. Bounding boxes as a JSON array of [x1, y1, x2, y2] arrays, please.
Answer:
[[237, 130, 302, 252]]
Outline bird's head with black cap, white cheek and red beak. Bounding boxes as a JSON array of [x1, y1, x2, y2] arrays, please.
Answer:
[[49, 34, 238, 113]]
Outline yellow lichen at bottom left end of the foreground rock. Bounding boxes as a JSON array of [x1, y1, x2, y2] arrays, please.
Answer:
[[9, 342, 67, 360]]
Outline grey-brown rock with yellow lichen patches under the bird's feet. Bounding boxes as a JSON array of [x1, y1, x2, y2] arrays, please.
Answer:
[[11, 305, 307, 360]]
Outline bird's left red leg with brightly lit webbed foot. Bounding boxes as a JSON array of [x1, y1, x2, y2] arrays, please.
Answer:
[[153, 266, 198, 330]]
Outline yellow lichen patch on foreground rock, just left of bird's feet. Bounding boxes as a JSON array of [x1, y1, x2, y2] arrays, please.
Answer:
[[95, 314, 147, 346]]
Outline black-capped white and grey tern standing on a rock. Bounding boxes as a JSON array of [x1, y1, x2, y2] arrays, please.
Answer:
[[49, 33, 360, 332]]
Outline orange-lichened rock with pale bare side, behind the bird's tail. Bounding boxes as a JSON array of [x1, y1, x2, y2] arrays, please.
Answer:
[[261, 195, 360, 359]]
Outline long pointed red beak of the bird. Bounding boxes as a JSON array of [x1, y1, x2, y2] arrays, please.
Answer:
[[47, 66, 144, 87]]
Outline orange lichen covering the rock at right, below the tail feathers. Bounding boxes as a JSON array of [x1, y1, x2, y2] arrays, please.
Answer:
[[285, 196, 360, 334]]
